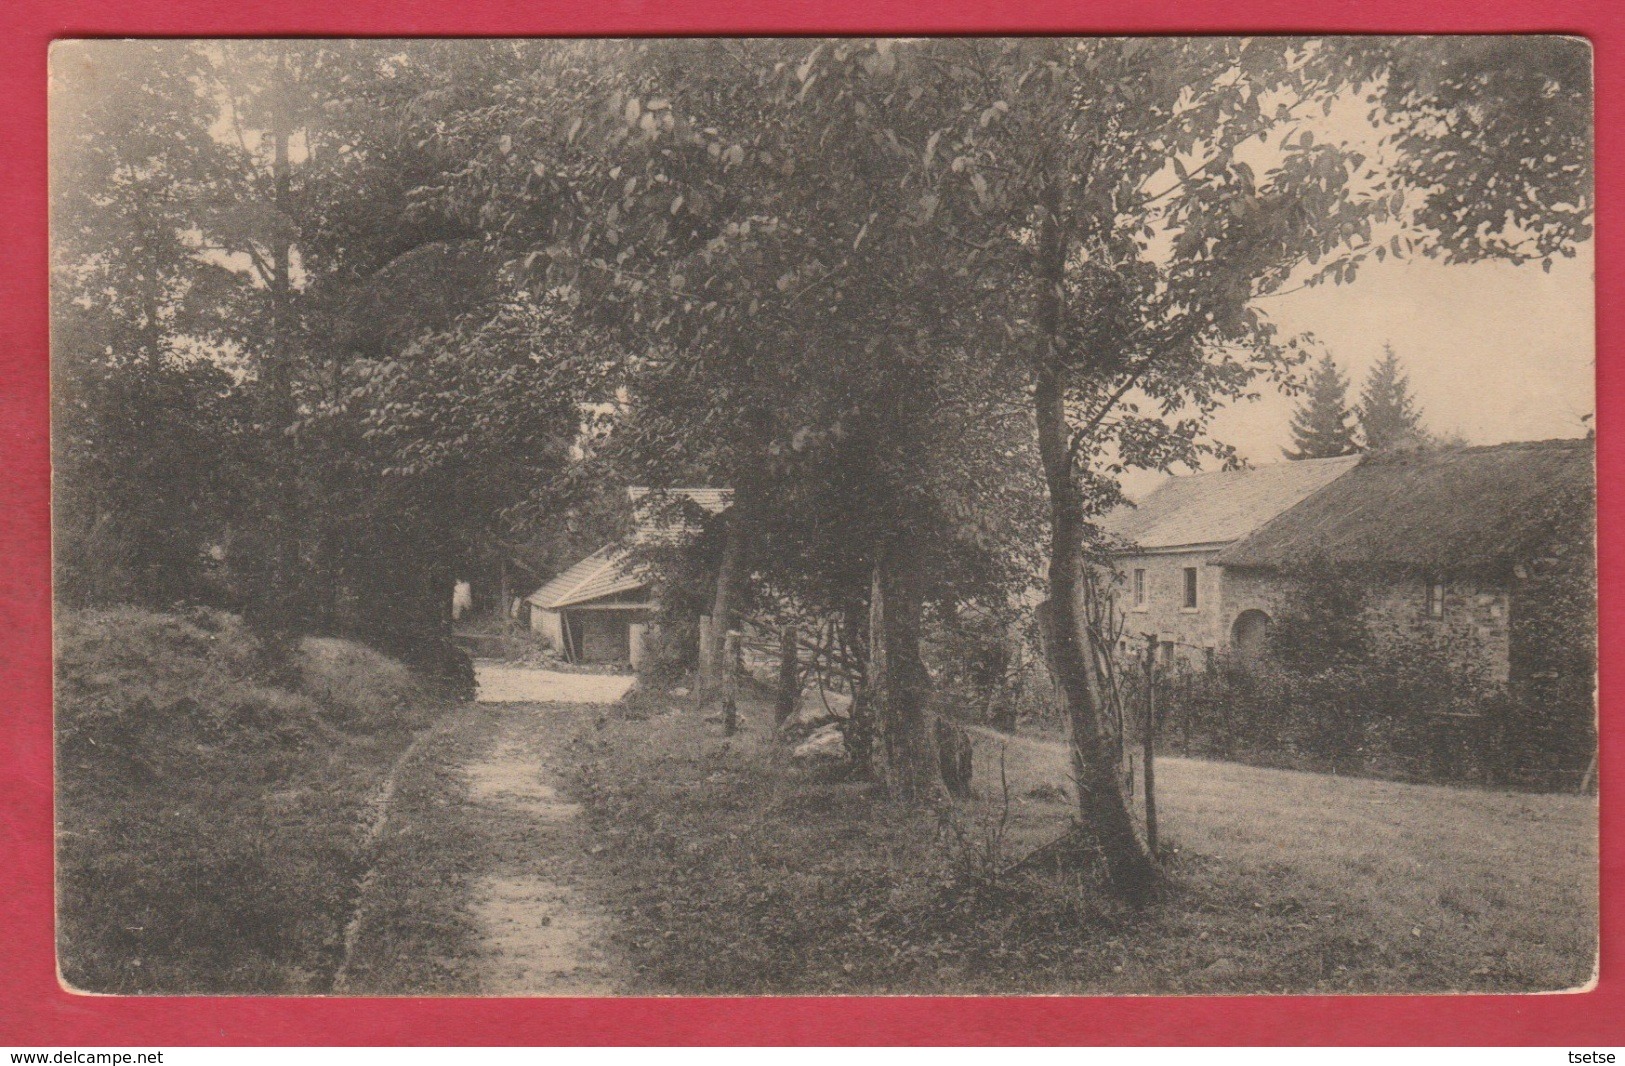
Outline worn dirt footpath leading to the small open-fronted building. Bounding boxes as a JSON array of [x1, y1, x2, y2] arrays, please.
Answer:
[[333, 663, 632, 996]]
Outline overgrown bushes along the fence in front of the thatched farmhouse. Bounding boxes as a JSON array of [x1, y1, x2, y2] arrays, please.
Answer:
[[1157, 577, 1589, 788]]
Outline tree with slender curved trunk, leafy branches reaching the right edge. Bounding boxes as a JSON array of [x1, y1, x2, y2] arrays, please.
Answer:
[[923, 39, 1591, 895]]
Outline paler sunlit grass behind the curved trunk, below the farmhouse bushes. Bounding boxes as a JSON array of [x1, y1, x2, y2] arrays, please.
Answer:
[[973, 731, 1597, 988]]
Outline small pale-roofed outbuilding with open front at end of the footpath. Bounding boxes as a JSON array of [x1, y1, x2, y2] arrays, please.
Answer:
[[525, 488, 730, 668]]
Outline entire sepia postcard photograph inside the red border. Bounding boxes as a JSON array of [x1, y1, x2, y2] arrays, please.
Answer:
[[49, 36, 1599, 1001]]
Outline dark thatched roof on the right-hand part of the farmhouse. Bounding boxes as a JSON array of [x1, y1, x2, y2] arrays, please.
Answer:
[[1214, 440, 1596, 570]]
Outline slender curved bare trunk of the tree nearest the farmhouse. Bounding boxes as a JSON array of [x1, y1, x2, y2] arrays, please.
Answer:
[[1034, 173, 1157, 902]]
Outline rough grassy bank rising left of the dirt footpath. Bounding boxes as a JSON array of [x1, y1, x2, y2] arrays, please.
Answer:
[[57, 609, 455, 993]]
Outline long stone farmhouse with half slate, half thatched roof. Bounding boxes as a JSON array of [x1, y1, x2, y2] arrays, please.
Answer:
[[1103, 440, 1596, 681]]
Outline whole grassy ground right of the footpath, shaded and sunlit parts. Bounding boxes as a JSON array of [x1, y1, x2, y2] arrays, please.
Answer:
[[552, 679, 1596, 995]]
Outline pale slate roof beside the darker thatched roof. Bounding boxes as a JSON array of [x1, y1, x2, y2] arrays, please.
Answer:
[[1100, 455, 1360, 549]]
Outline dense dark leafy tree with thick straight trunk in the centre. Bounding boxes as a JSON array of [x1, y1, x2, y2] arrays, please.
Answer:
[[394, 41, 1046, 795]]
